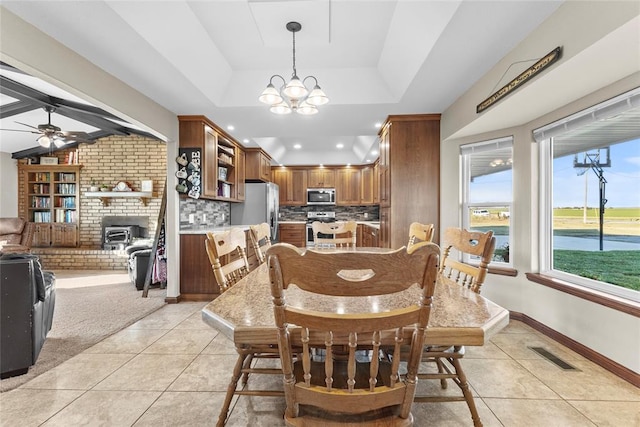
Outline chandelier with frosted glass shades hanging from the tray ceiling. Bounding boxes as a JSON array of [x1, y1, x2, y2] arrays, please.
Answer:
[[258, 21, 329, 115]]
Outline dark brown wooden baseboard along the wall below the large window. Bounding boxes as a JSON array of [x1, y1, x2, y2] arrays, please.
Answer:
[[509, 311, 640, 387]]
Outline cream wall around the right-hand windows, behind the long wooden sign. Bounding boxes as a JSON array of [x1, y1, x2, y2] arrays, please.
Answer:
[[440, 2, 640, 373]]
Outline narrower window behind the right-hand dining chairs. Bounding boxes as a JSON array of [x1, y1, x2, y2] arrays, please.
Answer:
[[460, 137, 513, 266]]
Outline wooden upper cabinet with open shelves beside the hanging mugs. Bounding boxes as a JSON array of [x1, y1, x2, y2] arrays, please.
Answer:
[[178, 116, 245, 202]]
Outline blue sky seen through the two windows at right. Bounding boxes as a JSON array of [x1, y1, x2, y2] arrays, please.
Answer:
[[470, 139, 640, 208]]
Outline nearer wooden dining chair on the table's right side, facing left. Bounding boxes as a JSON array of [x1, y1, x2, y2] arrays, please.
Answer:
[[414, 227, 496, 427]]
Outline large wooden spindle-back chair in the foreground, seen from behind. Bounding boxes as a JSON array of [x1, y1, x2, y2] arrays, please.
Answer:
[[267, 243, 439, 426]]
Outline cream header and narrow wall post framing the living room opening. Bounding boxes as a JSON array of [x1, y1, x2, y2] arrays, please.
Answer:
[[0, 6, 180, 297]]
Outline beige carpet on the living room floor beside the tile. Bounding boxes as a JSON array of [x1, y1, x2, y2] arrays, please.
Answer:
[[0, 270, 166, 392]]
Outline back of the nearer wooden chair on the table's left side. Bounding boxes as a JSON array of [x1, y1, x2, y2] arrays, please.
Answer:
[[204, 228, 249, 293]]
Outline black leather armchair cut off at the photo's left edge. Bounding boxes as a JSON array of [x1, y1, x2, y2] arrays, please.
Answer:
[[0, 254, 56, 378]]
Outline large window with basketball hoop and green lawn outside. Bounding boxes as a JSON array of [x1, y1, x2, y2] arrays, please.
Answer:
[[534, 90, 640, 301]]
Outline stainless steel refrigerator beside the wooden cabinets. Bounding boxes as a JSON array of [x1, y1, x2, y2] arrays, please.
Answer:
[[230, 182, 279, 242]]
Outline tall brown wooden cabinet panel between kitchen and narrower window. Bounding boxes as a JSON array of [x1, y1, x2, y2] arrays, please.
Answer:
[[378, 114, 440, 248]]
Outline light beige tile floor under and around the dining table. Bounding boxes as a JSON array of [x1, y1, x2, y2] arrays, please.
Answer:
[[0, 302, 640, 427]]
